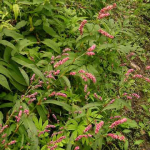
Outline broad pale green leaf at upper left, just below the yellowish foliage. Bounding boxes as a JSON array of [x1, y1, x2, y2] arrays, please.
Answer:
[[3, 29, 23, 40]]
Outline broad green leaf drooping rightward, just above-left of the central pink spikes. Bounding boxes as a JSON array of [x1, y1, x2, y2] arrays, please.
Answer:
[[42, 39, 60, 53]]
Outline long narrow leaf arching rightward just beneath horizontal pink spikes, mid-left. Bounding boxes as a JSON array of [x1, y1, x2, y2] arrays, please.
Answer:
[[42, 100, 71, 111]]
